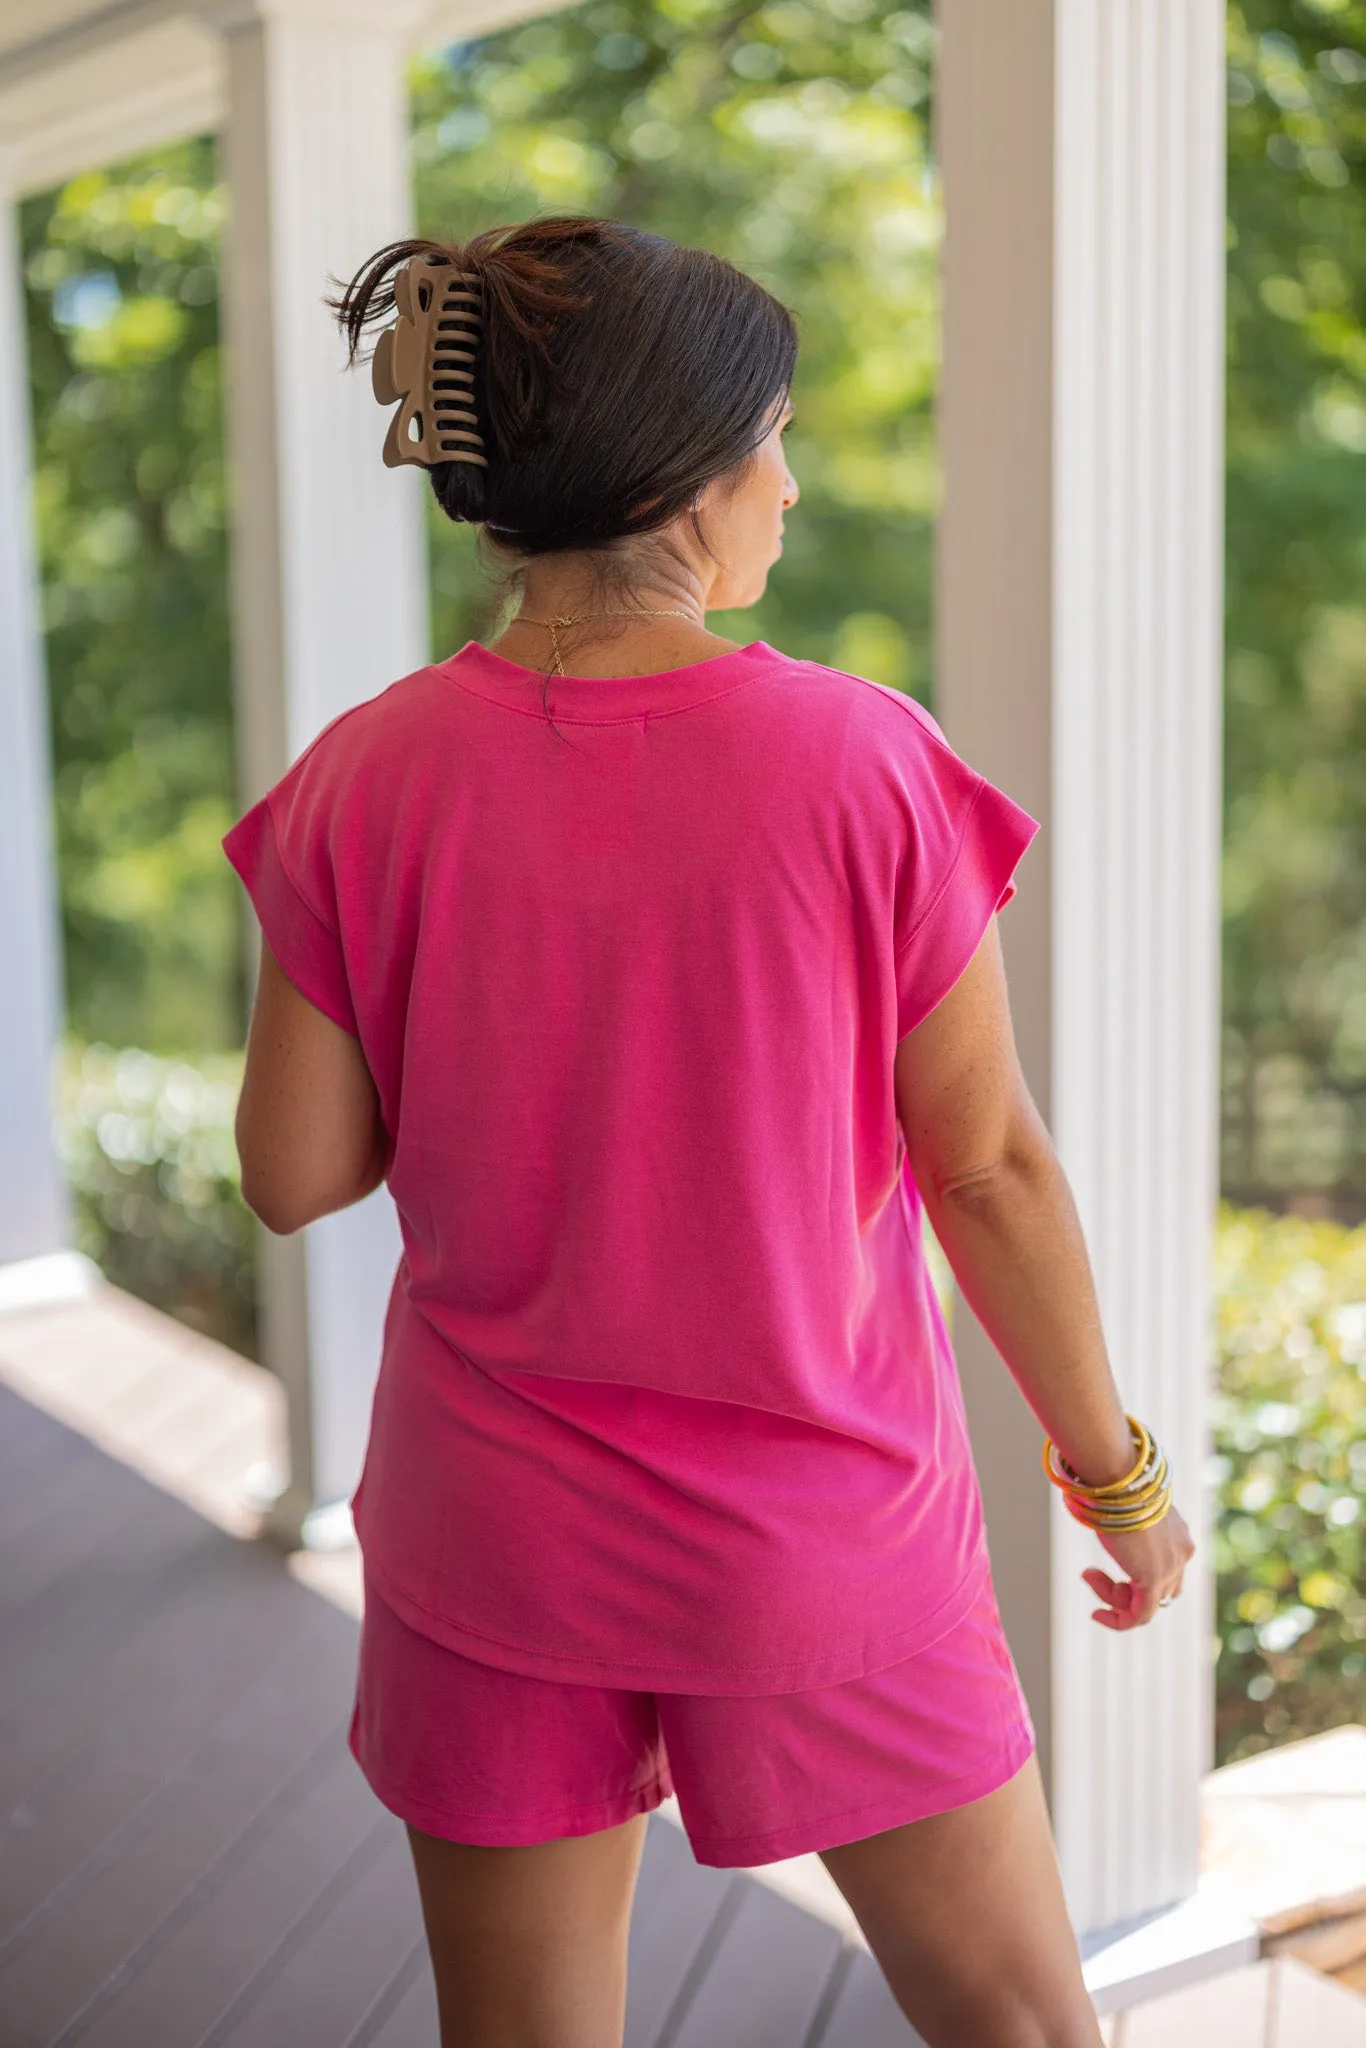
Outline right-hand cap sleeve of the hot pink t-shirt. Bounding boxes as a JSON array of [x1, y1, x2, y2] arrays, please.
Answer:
[[895, 741, 1038, 1038]]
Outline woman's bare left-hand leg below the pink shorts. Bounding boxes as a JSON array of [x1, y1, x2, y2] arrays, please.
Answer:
[[408, 1815, 645, 2048]]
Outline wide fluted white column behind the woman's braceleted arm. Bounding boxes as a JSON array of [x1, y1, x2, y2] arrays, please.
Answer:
[[936, 0, 1225, 1929]]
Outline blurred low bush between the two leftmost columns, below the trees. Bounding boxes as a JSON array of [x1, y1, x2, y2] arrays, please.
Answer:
[[57, 1042, 256, 1358]]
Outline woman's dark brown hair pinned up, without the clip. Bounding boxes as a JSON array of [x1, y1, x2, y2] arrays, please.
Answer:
[[328, 215, 797, 555]]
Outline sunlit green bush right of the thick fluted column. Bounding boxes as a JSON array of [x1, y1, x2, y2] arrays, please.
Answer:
[[1212, 1204, 1366, 1763]]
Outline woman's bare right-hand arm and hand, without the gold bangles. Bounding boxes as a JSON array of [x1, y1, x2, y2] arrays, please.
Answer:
[[895, 918, 1194, 1628]]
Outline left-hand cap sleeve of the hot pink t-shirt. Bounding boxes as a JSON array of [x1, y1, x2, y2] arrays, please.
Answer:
[[223, 735, 358, 1038]]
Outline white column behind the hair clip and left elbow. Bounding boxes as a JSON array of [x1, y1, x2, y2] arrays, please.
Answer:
[[211, 0, 428, 1534]]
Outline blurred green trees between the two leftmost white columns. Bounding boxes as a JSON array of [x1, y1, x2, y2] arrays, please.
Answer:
[[23, 141, 242, 1049]]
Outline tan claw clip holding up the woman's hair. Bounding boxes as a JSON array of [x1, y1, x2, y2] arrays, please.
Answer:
[[371, 256, 487, 469]]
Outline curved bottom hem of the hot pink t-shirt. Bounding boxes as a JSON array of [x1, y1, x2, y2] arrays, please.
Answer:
[[360, 1536, 991, 1698]]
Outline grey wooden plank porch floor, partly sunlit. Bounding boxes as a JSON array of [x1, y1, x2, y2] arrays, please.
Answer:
[[0, 1290, 1366, 2048]]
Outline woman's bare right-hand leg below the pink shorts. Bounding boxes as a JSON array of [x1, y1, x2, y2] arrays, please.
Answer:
[[823, 1759, 1100, 2048]]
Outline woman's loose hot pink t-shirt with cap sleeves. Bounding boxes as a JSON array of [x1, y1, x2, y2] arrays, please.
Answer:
[[225, 641, 1038, 1694]]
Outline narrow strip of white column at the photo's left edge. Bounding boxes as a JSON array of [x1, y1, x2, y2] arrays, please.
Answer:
[[0, 145, 68, 1266]]
